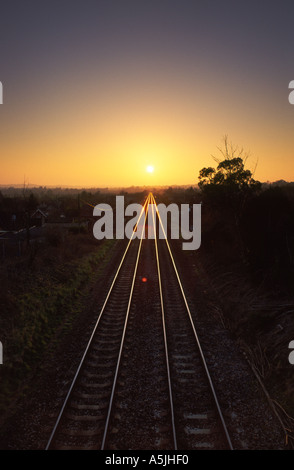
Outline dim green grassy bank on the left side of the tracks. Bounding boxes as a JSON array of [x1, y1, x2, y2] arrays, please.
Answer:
[[0, 235, 114, 414]]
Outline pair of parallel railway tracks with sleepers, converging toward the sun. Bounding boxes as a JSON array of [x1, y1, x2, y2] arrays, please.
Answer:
[[46, 194, 232, 450]]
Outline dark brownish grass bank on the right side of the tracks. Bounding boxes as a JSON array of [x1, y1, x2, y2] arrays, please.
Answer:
[[196, 252, 294, 435]]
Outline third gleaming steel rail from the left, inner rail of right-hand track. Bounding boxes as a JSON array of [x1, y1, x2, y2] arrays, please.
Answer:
[[151, 204, 178, 450]]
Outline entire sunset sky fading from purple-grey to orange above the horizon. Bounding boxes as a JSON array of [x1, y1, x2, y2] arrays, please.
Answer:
[[0, 0, 294, 187]]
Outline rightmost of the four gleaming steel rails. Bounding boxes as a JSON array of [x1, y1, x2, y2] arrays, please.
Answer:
[[151, 194, 233, 450]]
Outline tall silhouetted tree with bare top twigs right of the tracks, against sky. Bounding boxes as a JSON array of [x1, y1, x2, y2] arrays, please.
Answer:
[[198, 137, 261, 261]]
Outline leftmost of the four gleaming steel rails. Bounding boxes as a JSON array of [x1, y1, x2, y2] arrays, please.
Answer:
[[45, 195, 150, 450]]
